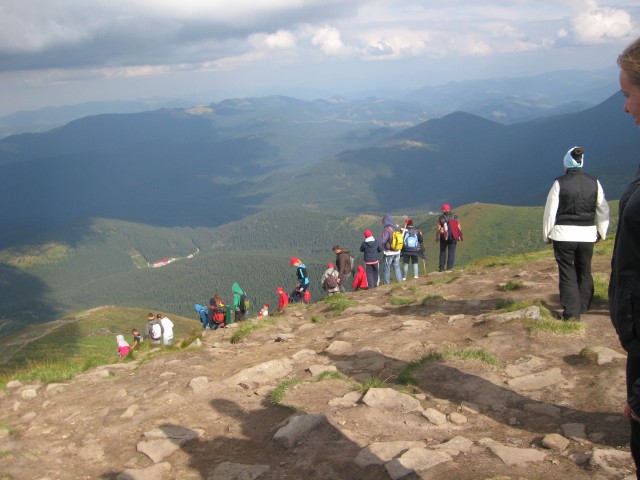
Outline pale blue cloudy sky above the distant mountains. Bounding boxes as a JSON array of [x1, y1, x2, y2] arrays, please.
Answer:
[[0, 0, 640, 115]]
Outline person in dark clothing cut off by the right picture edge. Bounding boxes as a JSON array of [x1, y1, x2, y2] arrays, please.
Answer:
[[609, 38, 640, 479]]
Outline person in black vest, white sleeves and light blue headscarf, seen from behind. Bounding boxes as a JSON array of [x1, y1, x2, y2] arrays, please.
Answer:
[[543, 147, 609, 320]]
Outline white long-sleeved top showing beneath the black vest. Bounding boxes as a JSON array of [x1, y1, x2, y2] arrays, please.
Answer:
[[542, 180, 609, 243]]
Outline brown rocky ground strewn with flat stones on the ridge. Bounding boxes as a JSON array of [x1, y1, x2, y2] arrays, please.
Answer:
[[0, 253, 635, 480]]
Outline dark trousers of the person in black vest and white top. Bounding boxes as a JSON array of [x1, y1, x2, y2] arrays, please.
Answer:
[[553, 240, 593, 320]]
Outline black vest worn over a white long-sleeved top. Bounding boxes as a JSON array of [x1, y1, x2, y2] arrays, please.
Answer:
[[556, 168, 598, 226]]
